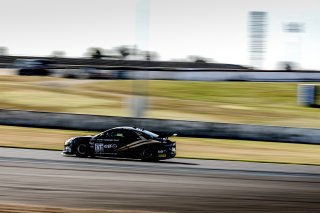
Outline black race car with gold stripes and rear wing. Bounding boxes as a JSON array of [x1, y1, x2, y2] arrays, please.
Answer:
[[62, 127, 176, 161]]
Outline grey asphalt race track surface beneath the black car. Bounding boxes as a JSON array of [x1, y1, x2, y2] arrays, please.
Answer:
[[0, 148, 320, 212]]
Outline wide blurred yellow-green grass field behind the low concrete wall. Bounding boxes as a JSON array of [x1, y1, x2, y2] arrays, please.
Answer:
[[0, 76, 320, 128]]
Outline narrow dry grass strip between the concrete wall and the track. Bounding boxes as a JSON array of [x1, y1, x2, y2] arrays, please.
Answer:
[[0, 126, 320, 165]]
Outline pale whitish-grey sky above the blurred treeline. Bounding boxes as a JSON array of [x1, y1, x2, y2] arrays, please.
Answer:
[[0, 0, 320, 69]]
